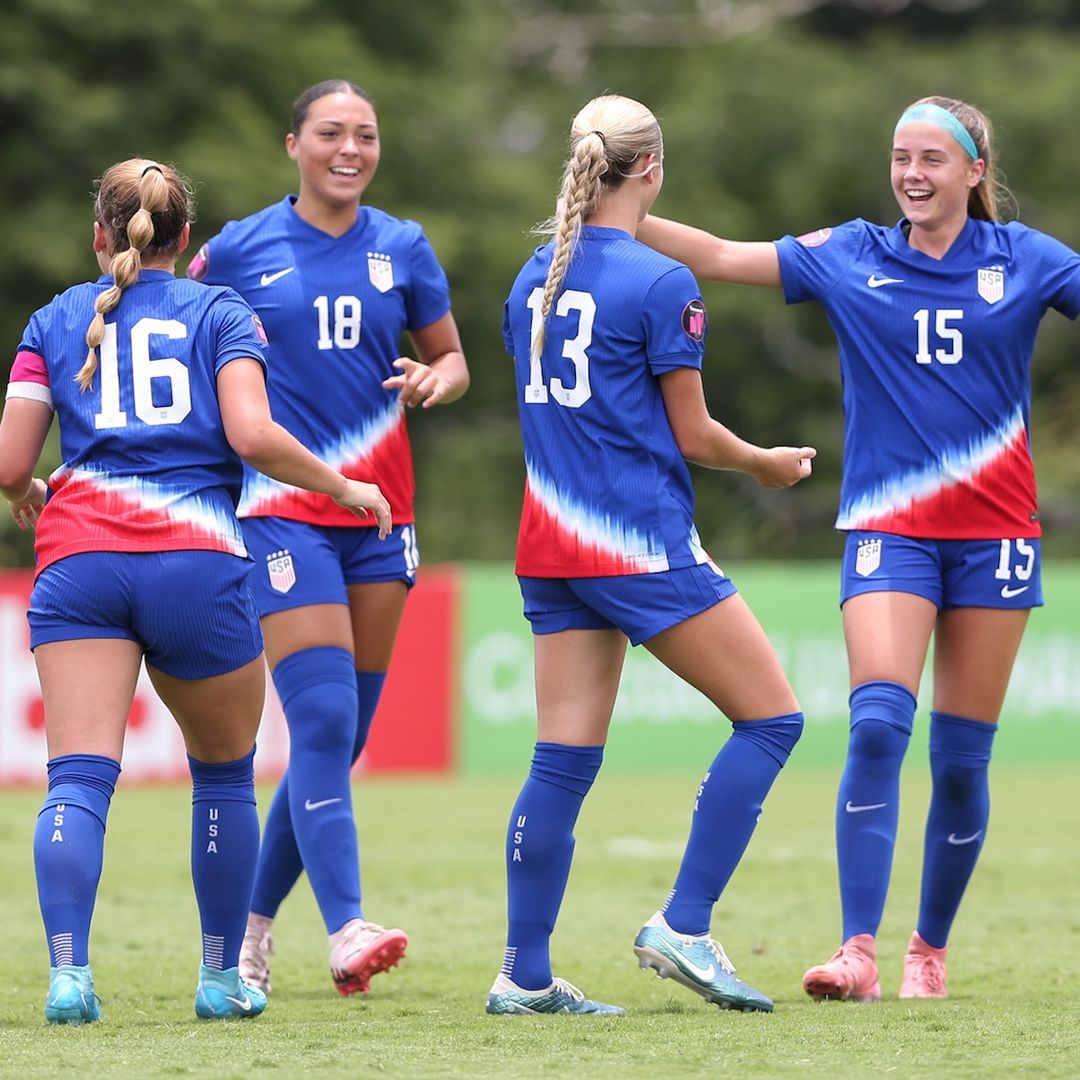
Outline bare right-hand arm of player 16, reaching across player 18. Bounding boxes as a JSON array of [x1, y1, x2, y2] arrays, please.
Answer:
[[217, 360, 392, 539]]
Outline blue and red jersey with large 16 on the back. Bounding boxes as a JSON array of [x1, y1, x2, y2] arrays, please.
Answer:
[[8, 270, 264, 572]]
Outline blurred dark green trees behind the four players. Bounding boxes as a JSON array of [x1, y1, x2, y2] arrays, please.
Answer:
[[0, 0, 1080, 565]]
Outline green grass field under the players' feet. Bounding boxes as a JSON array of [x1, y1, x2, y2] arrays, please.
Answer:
[[0, 766, 1080, 1080]]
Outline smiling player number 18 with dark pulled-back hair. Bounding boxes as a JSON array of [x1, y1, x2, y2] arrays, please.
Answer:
[[188, 80, 469, 995]]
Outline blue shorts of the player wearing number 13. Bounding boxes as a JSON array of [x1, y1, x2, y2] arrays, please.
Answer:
[[517, 563, 738, 645]]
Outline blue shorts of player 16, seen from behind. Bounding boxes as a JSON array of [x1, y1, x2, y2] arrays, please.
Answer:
[[27, 550, 262, 679]]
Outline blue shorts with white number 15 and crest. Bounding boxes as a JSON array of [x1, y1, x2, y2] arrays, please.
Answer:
[[840, 531, 1042, 609]]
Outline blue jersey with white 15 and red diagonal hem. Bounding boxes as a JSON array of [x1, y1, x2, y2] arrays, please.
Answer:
[[777, 219, 1080, 540]]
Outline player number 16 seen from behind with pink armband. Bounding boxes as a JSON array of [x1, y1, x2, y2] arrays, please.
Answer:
[[0, 159, 390, 1024]]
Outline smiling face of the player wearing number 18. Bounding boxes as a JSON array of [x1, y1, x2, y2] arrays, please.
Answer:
[[285, 92, 379, 212]]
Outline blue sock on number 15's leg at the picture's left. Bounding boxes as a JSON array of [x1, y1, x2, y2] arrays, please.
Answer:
[[836, 681, 916, 941]]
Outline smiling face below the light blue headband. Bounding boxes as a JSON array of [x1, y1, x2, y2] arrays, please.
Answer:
[[890, 121, 986, 232]]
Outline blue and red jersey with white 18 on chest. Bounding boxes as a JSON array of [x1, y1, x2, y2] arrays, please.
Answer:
[[188, 195, 450, 528]]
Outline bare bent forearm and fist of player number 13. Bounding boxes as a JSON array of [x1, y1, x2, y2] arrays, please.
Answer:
[[660, 367, 818, 487]]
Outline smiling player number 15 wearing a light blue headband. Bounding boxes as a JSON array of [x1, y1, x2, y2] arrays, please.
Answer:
[[640, 97, 1080, 1001]]
